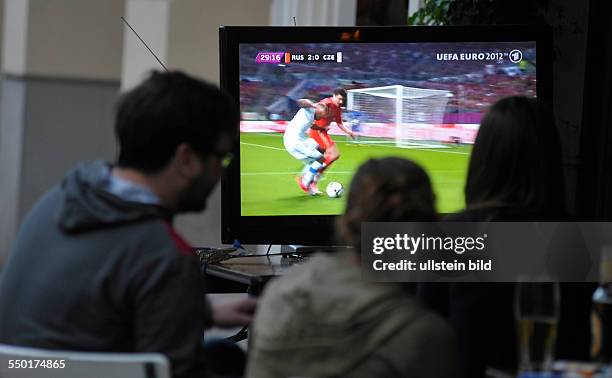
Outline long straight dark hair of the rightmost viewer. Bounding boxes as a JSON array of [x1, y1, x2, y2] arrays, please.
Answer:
[[465, 96, 565, 214]]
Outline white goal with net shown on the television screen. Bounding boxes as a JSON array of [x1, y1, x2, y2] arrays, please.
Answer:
[[347, 85, 452, 147]]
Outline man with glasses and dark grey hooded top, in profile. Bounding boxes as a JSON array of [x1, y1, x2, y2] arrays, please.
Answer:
[[0, 72, 255, 378]]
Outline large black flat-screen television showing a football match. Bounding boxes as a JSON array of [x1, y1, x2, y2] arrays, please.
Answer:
[[219, 26, 552, 245]]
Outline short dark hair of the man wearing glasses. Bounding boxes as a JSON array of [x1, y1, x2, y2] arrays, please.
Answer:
[[115, 72, 240, 173]]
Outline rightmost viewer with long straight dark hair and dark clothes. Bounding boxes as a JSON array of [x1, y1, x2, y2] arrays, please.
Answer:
[[418, 96, 594, 378]]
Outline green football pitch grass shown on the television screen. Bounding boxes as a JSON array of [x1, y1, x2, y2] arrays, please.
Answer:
[[240, 133, 471, 216]]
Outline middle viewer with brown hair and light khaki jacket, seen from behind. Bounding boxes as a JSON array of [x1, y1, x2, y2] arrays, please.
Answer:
[[247, 158, 456, 378]]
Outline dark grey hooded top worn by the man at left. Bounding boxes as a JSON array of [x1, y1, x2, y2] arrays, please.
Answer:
[[0, 161, 209, 378]]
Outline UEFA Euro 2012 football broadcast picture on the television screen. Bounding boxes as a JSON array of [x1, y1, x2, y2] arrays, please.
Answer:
[[239, 42, 536, 216]]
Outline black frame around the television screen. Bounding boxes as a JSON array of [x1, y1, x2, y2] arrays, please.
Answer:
[[219, 25, 553, 245]]
